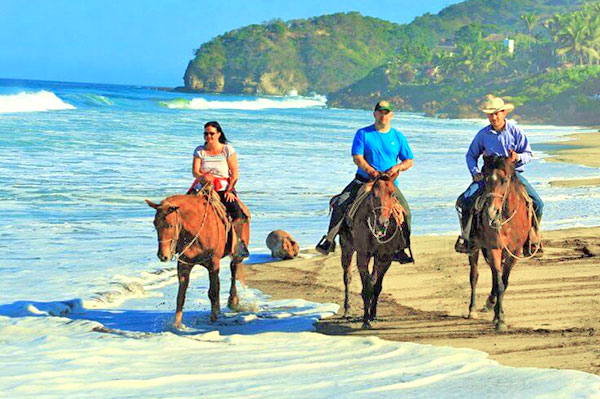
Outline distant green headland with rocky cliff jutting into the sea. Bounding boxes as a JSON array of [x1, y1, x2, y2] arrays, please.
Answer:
[[184, 12, 431, 94]]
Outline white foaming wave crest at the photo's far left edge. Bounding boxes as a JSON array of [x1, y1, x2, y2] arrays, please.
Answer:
[[0, 90, 75, 114]]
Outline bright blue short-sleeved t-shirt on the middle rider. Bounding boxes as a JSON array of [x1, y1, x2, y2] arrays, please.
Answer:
[[352, 125, 413, 178]]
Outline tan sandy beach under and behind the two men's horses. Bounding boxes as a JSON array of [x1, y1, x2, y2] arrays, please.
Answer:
[[247, 134, 600, 375]]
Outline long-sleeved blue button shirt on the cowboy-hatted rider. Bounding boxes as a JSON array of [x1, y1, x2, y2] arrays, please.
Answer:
[[466, 120, 533, 175]]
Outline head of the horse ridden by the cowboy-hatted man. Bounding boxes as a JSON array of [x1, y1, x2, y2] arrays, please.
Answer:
[[482, 156, 516, 225]]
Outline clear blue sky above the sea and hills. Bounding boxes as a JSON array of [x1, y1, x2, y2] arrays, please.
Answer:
[[0, 0, 459, 87]]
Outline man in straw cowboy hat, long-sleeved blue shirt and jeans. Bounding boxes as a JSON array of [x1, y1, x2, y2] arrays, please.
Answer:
[[455, 97, 544, 253]]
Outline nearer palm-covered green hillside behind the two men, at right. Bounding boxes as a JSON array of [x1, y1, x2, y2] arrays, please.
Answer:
[[328, 1, 600, 124]]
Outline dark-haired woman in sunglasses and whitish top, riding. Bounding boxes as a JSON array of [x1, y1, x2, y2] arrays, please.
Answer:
[[192, 121, 249, 257]]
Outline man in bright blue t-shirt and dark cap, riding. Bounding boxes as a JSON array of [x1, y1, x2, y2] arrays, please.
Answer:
[[316, 100, 413, 263]]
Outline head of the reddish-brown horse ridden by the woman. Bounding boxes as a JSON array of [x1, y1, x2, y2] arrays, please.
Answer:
[[146, 200, 181, 262]]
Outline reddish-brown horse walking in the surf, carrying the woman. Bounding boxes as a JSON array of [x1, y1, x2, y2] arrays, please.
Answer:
[[146, 194, 250, 328]]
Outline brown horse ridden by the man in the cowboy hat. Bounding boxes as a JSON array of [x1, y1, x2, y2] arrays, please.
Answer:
[[469, 156, 533, 331]]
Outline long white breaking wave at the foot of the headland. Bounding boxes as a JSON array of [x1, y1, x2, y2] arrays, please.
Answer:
[[159, 96, 327, 110]]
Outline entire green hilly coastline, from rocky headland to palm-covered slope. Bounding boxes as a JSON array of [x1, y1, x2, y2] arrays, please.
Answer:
[[183, 0, 600, 124]]
